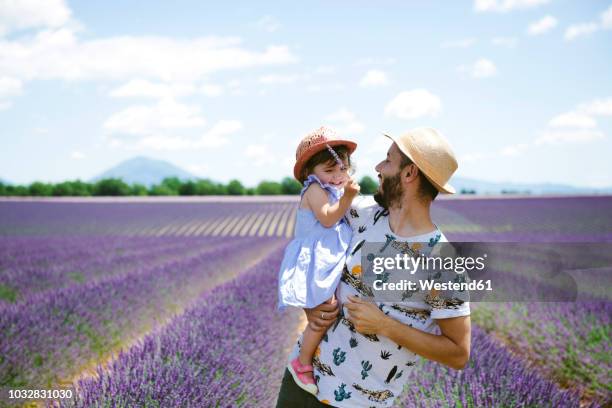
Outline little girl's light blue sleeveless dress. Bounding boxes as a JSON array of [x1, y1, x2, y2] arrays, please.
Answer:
[[278, 174, 352, 310]]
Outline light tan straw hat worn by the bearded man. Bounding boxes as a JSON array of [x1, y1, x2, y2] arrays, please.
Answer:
[[383, 127, 458, 194]]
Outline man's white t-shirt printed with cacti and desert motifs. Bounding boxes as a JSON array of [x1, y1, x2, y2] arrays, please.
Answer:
[[289, 196, 470, 408]]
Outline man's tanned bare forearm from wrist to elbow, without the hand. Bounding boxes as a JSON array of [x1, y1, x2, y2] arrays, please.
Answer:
[[380, 316, 469, 370]]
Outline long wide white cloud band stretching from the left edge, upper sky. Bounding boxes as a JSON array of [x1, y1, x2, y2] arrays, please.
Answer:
[[0, 28, 297, 82]]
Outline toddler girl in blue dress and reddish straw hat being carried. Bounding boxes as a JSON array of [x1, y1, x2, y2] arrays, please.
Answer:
[[278, 127, 359, 395]]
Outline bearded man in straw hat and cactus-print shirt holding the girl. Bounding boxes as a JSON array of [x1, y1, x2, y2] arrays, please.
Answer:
[[277, 128, 470, 408]]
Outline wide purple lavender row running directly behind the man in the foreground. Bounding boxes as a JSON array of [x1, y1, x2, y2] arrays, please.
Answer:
[[63, 247, 579, 407]]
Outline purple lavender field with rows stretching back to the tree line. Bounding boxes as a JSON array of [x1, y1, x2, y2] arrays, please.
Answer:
[[0, 196, 612, 407]]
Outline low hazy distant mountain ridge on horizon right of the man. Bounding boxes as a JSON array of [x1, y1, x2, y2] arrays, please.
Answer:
[[450, 177, 612, 195]]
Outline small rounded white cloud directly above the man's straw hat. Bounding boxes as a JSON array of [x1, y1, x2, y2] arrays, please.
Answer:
[[385, 89, 442, 119]]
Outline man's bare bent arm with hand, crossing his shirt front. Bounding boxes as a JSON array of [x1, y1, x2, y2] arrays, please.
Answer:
[[344, 296, 471, 370]]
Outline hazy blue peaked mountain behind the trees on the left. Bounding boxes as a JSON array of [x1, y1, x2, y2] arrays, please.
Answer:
[[89, 156, 196, 187]]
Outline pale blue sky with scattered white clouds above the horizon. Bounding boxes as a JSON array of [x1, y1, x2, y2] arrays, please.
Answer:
[[0, 0, 612, 187]]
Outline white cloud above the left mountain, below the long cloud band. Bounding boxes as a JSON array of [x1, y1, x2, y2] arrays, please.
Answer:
[[104, 99, 206, 135]]
